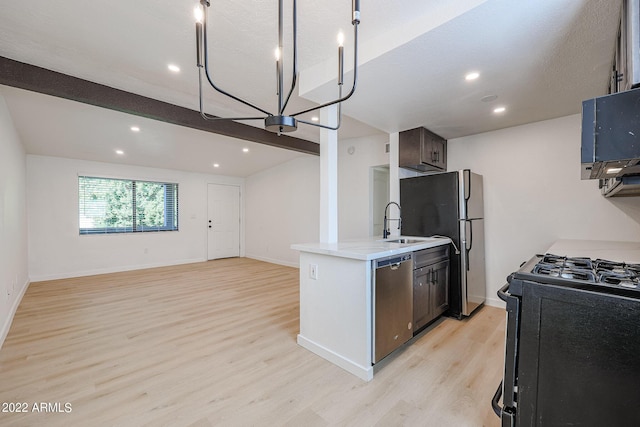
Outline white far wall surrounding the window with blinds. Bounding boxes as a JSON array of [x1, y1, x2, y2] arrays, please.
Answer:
[[27, 155, 243, 281]]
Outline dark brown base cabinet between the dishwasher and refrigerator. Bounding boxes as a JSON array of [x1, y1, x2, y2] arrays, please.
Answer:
[[413, 246, 449, 334]]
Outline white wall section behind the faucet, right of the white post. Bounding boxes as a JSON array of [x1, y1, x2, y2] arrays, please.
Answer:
[[338, 135, 389, 240]]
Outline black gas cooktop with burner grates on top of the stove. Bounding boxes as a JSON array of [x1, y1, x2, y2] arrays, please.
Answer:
[[516, 253, 640, 291]]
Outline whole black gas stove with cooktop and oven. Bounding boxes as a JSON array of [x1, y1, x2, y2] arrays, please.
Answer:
[[492, 253, 640, 427]]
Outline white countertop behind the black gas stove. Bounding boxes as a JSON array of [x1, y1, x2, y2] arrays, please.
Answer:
[[547, 240, 640, 264]]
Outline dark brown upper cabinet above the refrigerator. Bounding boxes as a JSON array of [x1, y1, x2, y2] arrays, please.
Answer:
[[398, 127, 447, 172]]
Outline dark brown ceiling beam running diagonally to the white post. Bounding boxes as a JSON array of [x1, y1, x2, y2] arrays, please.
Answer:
[[0, 56, 320, 155]]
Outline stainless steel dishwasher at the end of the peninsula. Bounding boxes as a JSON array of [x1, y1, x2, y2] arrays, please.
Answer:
[[373, 253, 413, 363]]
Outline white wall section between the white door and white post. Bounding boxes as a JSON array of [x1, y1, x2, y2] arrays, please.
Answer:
[[245, 155, 320, 267]]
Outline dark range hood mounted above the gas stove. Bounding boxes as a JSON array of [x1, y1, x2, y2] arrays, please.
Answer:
[[581, 89, 640, 184]]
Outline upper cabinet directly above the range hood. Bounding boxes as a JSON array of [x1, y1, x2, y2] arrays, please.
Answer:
[[609, 0, 640, 93]]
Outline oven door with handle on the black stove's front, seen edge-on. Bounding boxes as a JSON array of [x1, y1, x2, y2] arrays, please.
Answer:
[[491, 283, 521, 427]]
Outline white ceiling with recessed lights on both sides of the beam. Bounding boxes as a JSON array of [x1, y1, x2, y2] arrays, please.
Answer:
[[0, 0, 621, 176]]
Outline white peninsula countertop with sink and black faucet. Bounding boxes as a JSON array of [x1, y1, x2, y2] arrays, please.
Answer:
[[291, 236, 451, 261]]
